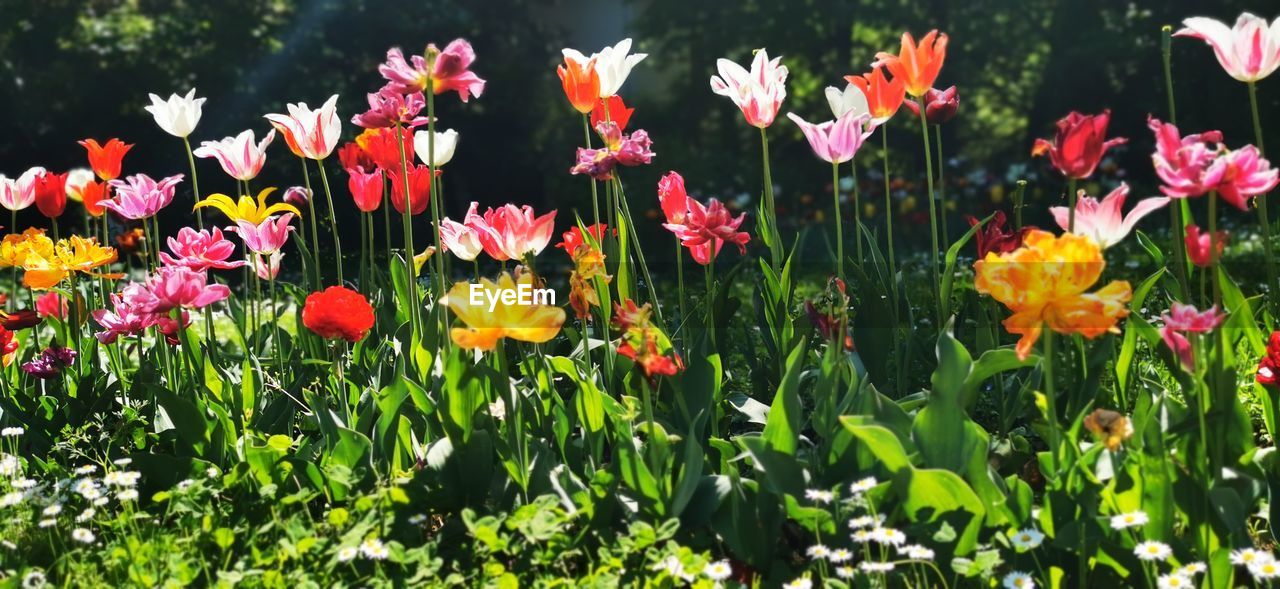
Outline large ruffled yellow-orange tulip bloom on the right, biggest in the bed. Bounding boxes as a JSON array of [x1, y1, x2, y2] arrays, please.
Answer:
[[974, 230, 1133, 360]]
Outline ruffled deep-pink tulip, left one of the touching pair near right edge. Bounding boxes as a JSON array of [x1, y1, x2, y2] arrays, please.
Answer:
[[1147, 118, 1222, 198]]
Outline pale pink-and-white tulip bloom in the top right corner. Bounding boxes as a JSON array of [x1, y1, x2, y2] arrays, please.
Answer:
[[1174, 13, 1280, 82]]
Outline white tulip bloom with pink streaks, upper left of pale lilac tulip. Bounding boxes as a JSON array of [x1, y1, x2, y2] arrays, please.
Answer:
[[712, 49, 787, 129]]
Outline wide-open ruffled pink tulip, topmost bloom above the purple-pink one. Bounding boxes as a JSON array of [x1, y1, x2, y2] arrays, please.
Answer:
[[378, 38, 485, 102]]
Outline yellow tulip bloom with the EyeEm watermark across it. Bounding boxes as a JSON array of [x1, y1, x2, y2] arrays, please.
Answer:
[[440, 273, 564, 351]]
